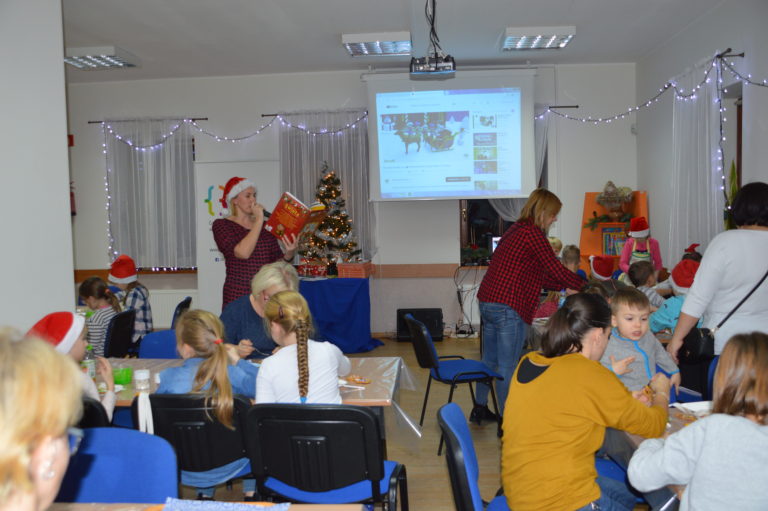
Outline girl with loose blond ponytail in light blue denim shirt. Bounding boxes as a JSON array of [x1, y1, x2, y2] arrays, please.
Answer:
[[157, 310, 258, 500]]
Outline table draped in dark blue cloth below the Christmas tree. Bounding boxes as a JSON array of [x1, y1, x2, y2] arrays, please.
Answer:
[[299, 278, 383, 353]]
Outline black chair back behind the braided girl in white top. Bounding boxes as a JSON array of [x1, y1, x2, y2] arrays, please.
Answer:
[[247, 404, 384, 503]]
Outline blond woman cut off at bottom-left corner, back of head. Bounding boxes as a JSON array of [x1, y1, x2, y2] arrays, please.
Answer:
[[0, 331, 82, 511]]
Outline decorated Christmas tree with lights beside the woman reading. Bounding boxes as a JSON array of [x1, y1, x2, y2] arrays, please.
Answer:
[[299, 162, 361, 264]]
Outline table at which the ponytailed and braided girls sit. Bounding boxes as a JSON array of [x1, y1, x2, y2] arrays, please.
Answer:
[[109, 357, 414, 407]]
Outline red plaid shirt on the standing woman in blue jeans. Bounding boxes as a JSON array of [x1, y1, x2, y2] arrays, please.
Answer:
[[477, 220, 585, 325]]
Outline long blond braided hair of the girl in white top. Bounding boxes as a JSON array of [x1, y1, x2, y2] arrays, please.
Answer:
[[264, 291, 312, 403]]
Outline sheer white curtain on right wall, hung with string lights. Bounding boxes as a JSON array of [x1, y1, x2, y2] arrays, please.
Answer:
[[668, 60, 725, 257]]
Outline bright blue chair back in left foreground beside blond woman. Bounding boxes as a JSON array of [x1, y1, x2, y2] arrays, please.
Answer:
[[56, 428, 179, 504]]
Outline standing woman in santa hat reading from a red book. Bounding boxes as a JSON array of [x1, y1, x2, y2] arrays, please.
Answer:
[[211, 177, 298, 309]]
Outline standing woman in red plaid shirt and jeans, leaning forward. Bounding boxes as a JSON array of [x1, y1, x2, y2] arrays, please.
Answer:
[[470, 188, 585, 422]]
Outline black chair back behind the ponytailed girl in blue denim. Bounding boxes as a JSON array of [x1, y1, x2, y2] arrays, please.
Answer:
[[131, 394, 251, 472]]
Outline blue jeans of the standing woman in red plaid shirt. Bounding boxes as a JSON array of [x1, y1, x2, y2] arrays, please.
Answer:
[[477, 302, 528, 413]]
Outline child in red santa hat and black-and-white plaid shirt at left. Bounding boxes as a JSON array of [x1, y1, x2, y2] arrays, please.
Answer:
[[107, 254, 152, 344]]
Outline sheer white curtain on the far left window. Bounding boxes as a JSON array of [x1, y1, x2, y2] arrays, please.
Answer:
[[104, 119, 196, 268]]
